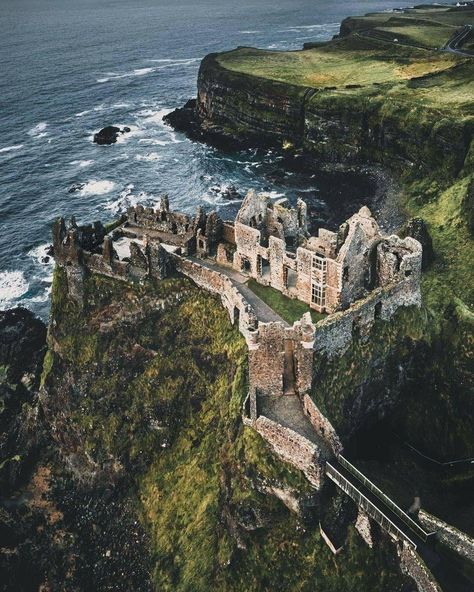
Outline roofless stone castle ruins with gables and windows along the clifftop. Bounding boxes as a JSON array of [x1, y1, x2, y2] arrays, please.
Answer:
[[54, 191, 421, 324]]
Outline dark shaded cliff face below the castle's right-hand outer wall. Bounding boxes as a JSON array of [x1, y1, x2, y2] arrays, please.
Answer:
[[313, 301, 474, 460]]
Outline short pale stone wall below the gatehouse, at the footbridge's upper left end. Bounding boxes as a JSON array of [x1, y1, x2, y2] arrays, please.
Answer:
[[252, 415, 324, 489]]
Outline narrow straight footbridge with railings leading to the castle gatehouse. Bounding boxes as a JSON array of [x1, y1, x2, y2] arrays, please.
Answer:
[[326, 454, 434, 549]]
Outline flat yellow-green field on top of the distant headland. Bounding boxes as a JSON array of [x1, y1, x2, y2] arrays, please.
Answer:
[[217, 7, 474, 105]]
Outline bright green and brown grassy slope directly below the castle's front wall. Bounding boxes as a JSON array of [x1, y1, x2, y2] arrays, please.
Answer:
[[43, 270, 410, 592]]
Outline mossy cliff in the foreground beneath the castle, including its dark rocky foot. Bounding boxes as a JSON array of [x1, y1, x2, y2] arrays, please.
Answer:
[[16, 268, 410, 592]]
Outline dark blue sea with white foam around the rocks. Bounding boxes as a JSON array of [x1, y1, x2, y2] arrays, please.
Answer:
[[0, 0, 418, 318]]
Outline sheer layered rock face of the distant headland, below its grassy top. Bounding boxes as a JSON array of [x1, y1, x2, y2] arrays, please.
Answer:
[[197, 54, 473, 177]]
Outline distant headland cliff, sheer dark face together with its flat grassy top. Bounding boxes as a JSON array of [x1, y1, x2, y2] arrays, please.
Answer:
[[197, 39, 474, 178]]
